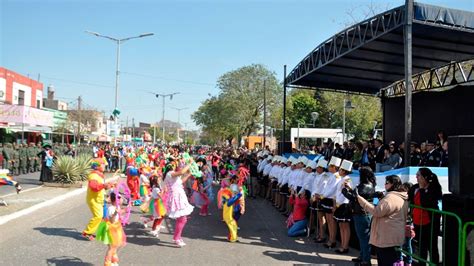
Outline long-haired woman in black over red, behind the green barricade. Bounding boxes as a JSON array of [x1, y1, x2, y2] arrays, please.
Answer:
[[408, 167, 443, 265]]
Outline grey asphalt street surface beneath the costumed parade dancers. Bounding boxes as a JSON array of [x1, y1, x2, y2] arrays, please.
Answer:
[[0, 183, 358, 265]]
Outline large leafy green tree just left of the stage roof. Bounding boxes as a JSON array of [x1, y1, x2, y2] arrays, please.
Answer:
[[192, 64, 282, 142]]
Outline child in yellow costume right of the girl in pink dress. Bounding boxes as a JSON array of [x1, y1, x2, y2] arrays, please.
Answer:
[[221, 184, 242, 242]]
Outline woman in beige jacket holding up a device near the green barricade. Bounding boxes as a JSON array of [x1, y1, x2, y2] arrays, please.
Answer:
[[353, 175, 408, 266]]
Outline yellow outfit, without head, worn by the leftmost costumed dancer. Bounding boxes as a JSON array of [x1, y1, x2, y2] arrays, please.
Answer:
[[84, 170, 105, 235]]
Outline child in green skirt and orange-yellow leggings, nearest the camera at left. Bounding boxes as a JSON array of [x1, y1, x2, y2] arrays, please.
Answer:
[[97, 192, 126, 266]]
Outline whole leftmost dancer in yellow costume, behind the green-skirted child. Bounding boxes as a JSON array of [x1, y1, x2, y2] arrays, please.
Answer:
[[82, 160, 113, 240]]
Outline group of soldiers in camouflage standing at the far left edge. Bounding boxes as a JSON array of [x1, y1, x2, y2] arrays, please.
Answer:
[[0, 142, 42, 175]]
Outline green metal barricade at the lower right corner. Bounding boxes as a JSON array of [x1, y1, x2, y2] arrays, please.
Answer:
[[400, 204, 462, 266]]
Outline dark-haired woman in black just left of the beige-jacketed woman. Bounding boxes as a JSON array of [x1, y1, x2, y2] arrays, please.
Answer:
[[342, 166, 375, 265]]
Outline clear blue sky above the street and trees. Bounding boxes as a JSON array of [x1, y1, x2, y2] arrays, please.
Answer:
[[0, 0, 474, 128]]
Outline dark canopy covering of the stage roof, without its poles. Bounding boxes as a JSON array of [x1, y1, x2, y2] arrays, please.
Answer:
[[286, 3, 474, 95]]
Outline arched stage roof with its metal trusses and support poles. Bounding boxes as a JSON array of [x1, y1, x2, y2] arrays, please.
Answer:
[[282, 0, 474, 165]]
